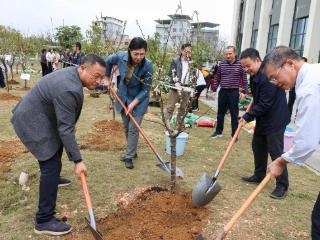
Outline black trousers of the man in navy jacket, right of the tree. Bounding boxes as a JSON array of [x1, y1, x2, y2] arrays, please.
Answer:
[[252, 129, 289, 189]]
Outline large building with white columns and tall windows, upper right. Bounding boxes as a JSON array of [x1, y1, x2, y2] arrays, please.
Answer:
[[231, 0, 320, 63]]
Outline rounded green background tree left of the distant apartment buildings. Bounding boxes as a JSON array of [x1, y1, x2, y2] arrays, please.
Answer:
[[54, 25, 83, 48]]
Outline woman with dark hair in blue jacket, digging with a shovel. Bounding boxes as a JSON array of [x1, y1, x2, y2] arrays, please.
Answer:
[[106, 37, 153, 169]]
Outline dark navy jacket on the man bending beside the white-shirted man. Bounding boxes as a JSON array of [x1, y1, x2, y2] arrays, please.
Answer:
[[242, 71, 290, 135]]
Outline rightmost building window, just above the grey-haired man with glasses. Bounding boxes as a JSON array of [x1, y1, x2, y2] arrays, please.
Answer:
[[290, 17, 308, 56]]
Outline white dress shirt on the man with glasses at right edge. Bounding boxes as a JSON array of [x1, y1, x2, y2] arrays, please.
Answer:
[[282, 63, 320, 165]]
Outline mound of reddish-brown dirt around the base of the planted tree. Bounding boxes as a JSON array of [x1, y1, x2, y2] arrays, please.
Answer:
[[67, 187, 209, 240]]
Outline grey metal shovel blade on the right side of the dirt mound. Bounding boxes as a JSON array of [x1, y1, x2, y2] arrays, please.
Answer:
[[192, 173, 221, 207]]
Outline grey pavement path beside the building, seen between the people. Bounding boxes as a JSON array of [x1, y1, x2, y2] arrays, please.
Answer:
[[200, 91, 320, 176]]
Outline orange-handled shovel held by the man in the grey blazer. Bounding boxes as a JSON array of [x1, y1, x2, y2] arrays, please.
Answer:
[[80, 172, 103, 240]]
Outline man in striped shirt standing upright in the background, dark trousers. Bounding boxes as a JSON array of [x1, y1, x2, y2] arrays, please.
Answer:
[[211, 46, 247, 138]]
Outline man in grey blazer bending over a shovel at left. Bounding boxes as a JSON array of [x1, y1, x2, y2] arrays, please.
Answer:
[[11, 54, 106, 235]]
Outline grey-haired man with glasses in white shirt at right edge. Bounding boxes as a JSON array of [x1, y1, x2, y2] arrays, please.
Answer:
[[262, 46, 320, 240]]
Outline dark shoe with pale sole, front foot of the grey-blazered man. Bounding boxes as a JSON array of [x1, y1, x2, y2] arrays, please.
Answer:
[[34, 217, 72, 236]]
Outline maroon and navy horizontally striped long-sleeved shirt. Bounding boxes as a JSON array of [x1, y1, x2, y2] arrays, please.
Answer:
[[215, 60, 248, 93]]
